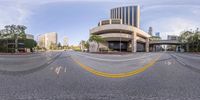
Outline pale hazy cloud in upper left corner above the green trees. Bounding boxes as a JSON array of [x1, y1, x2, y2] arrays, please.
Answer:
[[0, 1, 32, 28]]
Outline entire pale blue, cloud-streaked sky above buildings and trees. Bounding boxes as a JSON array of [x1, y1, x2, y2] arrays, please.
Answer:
[[0, 0, 200, 45]]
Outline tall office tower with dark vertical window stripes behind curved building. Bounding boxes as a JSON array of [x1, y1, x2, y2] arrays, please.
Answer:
[[110, 5, 140, 28]]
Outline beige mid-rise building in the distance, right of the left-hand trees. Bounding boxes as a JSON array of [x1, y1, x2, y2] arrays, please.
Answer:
[[38, 32, 57, 49]]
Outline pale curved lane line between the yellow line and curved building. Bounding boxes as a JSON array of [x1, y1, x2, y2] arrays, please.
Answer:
[[70, 53, 153, 62]]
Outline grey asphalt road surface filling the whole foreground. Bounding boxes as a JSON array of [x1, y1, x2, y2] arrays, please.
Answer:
[[0, 51, 200, 100]]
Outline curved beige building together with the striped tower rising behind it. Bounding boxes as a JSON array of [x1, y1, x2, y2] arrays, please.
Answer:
[[89, 6, 151, 52]]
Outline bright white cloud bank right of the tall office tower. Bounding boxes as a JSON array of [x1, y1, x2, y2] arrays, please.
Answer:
[[141, 4, 200, 39]]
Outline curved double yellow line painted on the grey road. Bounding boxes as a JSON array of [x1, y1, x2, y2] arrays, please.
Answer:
[[72, 55, 161, 78]]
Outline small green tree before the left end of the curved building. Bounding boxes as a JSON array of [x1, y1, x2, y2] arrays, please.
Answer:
[[89, 35, 104, 51]]
